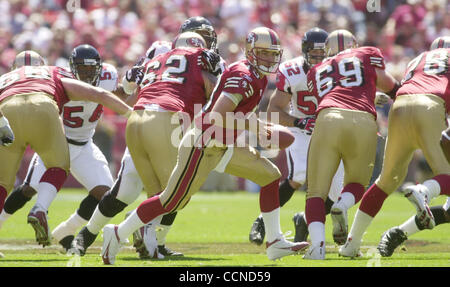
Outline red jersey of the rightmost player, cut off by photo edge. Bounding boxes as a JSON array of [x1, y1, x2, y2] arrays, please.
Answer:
[[397, 48, 450, 112]]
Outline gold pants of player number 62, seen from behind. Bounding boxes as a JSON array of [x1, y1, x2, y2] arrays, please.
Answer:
[[126, 110, 181, 197]]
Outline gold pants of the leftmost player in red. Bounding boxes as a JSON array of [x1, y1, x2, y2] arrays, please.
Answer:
[[0, 93, 70, 195]]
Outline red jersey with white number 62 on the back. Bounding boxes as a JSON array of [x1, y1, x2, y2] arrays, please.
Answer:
[[134, 48, 211, 119]]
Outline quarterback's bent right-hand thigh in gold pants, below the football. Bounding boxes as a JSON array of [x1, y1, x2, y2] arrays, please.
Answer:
[[225, 146, 281, 186]]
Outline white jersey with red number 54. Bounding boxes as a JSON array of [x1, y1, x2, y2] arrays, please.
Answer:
[[62, 63, 119, 142]]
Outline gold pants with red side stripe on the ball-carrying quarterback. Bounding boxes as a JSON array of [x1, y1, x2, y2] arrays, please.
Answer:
[[159, 129, 281, 212]]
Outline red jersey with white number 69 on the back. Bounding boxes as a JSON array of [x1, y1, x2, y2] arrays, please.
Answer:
[[308, 47, 385, 117]]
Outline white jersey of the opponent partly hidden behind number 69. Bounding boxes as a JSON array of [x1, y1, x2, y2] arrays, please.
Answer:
[[276, 56, 319, 118]]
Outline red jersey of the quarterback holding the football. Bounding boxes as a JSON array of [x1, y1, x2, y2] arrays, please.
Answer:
[[200, 60, 267, 144]]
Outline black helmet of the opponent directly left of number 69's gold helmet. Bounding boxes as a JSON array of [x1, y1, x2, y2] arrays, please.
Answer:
[[302, 27, 328, 66]]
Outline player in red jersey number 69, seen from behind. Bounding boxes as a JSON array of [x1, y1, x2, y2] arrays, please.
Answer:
[[304, 30, 399, 260]]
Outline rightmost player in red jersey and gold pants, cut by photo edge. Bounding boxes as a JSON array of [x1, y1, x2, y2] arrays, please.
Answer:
[[339, 35, 450, 257]]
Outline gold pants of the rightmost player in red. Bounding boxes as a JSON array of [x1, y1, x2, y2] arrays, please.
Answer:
[[375, 94, 450, 194]]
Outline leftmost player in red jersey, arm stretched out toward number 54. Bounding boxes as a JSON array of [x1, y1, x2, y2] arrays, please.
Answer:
[[0, 51, 131, 246]]
